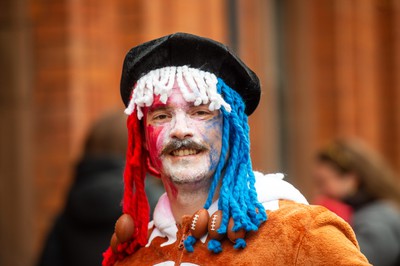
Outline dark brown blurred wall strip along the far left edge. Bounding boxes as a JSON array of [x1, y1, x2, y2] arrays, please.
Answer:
[[0, 1, 35, 266]]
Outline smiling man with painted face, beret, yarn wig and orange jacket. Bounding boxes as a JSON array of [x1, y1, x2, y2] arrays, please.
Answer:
[[103, 33, 369, 265]]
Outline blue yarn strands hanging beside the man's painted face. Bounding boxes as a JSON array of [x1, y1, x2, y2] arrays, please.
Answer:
[[184, 78, 267, 253]]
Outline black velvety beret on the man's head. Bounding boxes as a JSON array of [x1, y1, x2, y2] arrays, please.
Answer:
[[121, 33, 261, 115]]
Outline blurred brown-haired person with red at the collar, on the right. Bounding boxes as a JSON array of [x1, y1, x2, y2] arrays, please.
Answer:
[[313, 139, 400, 266]]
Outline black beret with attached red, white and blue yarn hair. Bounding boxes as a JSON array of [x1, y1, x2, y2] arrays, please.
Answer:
[[103, 33, 267, 265]]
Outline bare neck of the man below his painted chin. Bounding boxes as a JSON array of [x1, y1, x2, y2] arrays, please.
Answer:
[[162, 178, 218, 224]]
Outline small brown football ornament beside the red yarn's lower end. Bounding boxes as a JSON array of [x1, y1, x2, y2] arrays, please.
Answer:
[[110, 213, 135, 253]]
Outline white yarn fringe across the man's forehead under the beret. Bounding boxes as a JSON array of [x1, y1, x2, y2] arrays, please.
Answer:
[[125, 66, 231, 120]]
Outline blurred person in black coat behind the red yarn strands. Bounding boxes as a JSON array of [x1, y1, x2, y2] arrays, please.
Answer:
[[38, 111, 163, 266]]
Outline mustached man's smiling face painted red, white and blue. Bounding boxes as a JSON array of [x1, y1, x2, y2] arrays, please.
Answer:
[[144, 84, 223, 184]]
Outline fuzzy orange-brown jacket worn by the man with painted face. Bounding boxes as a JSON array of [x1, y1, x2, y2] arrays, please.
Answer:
[[116, 200, 370, 266]]
